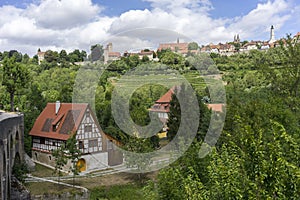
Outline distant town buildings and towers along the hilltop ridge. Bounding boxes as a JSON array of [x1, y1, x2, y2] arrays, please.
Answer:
[[37, 25, 300, 63]]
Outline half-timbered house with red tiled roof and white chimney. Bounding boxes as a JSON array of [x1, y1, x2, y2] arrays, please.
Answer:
[[29, 102, 123, 171]]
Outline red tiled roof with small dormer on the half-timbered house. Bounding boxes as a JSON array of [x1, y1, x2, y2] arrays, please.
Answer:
[[29, 103, 88, 140]]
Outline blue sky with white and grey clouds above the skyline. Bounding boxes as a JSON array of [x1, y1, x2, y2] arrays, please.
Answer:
[[0, 0, 300, 56]]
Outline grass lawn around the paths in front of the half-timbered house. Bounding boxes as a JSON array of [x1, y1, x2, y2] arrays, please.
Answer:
[[25, 164, 157, 200]]
